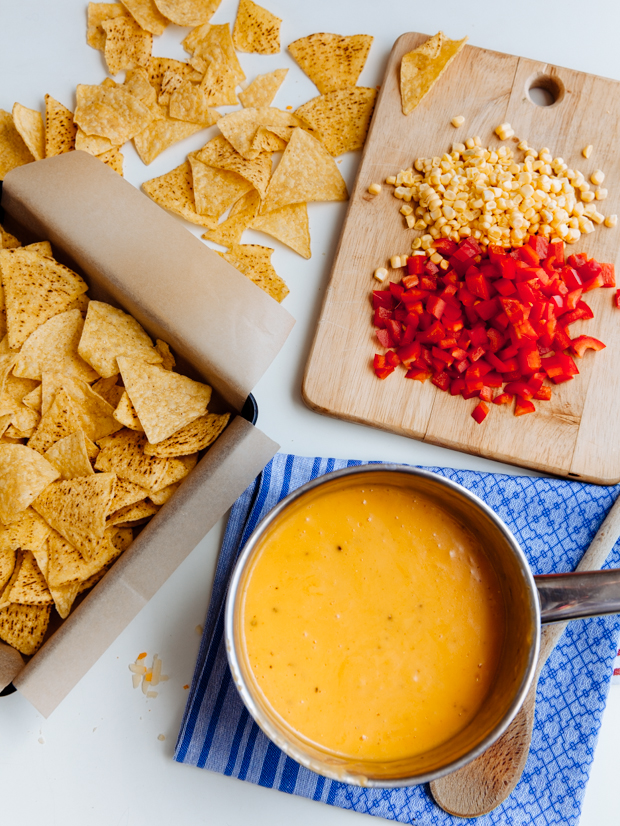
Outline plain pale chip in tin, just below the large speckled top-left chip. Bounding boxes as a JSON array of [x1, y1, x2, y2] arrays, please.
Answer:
[[13, 310, 98, 384]]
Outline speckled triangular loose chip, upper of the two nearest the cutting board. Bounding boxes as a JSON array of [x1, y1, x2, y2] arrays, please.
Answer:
[[288, 32, 373, 95]]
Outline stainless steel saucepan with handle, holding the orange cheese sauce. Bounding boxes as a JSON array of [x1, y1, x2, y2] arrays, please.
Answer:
[[225, 465, 620, 787]]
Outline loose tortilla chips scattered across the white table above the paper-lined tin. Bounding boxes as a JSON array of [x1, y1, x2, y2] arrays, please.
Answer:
[[0, 0, 376, 301]]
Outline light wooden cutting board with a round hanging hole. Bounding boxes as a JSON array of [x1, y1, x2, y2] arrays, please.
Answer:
[[303, 33, 620, 484]]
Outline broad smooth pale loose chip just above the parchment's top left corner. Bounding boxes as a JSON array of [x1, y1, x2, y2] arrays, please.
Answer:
[[75, 83, 153, 146]]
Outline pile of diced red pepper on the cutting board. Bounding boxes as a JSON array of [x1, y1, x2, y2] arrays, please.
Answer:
[[372, 235, 620, 423]]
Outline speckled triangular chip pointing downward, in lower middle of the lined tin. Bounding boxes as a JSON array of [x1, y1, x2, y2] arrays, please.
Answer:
[[33, 473, 116, 560]]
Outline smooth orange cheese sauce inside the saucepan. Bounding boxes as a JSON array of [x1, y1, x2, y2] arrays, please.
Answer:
[[242, 482, 504, 761]]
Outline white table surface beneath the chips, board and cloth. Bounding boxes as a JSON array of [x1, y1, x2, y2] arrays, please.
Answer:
[[0, 0, 620, 826]]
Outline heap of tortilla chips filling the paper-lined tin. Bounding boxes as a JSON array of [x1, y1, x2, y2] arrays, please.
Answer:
[[0, 235, 229, 655]]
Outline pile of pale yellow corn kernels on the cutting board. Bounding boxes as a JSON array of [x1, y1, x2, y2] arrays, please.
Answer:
[[373, 123, 617, 268]]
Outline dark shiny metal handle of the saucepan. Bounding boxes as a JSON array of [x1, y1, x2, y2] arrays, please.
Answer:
[[534, 568, 620, 624]]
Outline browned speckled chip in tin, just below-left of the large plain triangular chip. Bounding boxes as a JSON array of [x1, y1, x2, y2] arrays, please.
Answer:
[[94, 430, 191, 492]]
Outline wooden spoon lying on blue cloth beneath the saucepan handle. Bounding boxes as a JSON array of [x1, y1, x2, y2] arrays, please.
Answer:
[[430, 497, 620, 817]]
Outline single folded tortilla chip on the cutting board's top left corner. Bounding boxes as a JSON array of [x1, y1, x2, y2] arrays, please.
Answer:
[[400, 32, 467, 115]]
